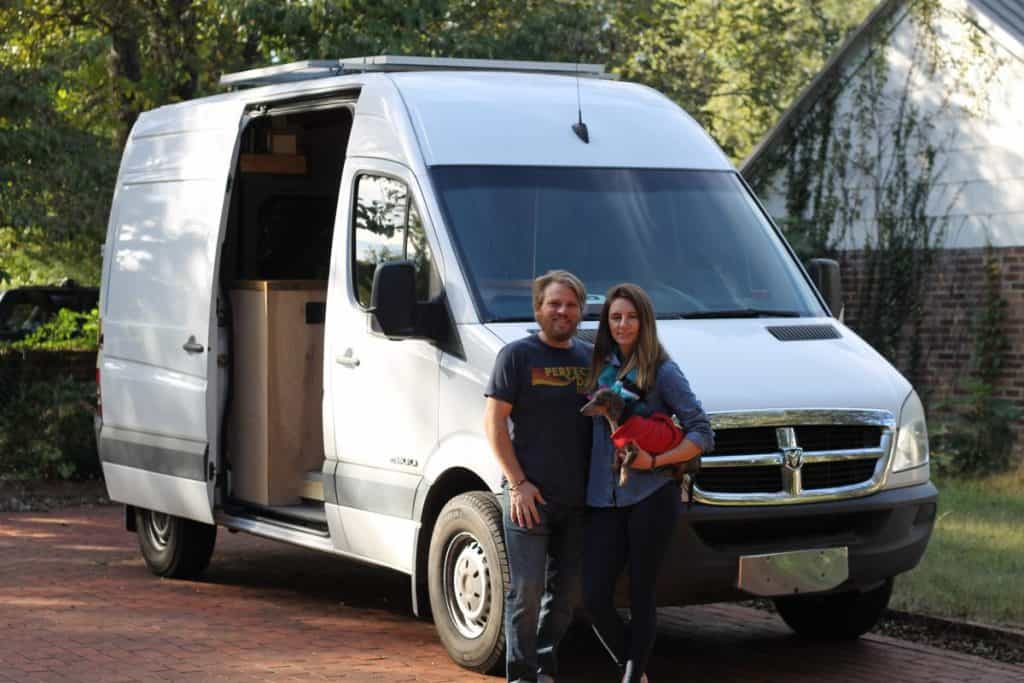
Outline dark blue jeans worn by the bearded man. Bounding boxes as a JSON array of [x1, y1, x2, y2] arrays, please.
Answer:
[[502, 489, 585, 681]]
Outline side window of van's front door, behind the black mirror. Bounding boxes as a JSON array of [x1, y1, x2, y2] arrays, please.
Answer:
[[352, 175, 440, 308]]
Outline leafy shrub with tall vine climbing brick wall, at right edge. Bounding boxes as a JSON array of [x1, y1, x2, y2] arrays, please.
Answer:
[[932, 247, 1024, 475]]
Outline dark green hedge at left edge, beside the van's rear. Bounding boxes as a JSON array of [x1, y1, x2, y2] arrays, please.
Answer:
[[0, 366, 99, 479]]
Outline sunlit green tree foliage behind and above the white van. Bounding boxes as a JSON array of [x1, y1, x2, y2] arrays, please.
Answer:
[[0, 0, 874, 285]]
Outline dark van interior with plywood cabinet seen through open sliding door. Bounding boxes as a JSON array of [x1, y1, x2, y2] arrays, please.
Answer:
[[218, 95, 355, 532]]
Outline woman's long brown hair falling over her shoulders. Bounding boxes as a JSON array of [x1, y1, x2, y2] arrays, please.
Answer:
[[587, 283, 669, 391]]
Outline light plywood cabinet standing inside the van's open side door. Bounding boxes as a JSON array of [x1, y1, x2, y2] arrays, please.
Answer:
[[228, 281, 327, 506]]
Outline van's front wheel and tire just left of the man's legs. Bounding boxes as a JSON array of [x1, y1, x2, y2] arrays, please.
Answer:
[[427, 492, 509, 673]]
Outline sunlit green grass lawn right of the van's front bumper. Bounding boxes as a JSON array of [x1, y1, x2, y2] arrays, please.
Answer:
[[890, 466, 1024, 630]]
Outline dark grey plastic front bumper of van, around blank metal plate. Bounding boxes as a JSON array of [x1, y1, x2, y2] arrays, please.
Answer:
[[657, 482, 938, 605]]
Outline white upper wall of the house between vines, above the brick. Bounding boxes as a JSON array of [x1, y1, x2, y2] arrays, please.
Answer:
[[761, 2, 1024, 249]]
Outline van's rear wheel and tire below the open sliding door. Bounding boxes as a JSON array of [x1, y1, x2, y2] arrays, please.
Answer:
[[135, 508, 217, 579]]
